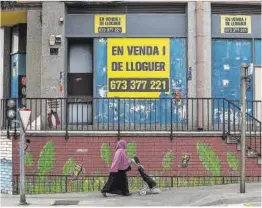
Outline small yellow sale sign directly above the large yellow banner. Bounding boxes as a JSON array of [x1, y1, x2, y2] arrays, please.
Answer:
[[95, 15, 126, 33]]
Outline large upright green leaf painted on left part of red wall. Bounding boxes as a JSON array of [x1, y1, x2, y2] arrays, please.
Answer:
[[38, 141, 55, 175]]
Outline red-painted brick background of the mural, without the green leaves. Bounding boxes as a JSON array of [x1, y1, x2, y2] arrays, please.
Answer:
[[13, 137, 261, 176]]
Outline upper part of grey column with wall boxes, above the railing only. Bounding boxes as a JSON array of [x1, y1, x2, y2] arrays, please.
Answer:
[[41, 1, 66, 98]]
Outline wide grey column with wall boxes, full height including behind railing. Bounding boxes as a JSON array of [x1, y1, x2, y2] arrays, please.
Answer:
[[41, 1, 67, 129]]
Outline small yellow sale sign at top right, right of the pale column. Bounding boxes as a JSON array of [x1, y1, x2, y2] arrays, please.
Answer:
[[220, 15, 251, 34]]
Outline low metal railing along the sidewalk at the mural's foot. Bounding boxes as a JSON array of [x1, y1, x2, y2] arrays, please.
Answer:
[[13, 175, 261, 194]]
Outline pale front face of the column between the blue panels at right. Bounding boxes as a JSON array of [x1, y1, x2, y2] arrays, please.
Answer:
[[196, 1, 212, 130]]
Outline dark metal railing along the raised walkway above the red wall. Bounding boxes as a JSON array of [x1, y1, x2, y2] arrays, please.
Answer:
[[0, 98, 259, 132]]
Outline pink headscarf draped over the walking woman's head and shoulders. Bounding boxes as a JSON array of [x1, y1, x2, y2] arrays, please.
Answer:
[[110, 140, 131, 173]]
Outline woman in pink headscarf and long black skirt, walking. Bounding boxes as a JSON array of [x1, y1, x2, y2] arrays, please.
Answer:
[[101, 140, 132, 197]]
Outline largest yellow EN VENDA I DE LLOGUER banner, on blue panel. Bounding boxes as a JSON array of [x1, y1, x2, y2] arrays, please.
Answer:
[[107, 38, 170, 98]]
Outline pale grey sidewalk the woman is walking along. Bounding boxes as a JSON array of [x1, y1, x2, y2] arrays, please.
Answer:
[[1, 183, 261, 206]]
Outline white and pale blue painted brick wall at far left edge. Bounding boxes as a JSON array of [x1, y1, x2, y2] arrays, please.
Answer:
[[0, 136, 12, 194]]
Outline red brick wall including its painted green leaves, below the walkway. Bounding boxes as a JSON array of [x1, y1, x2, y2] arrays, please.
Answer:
[[13, 137, 261, 176]]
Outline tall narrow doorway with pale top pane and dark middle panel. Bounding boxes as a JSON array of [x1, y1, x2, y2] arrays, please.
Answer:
[[67, 39, 93, 124]]
